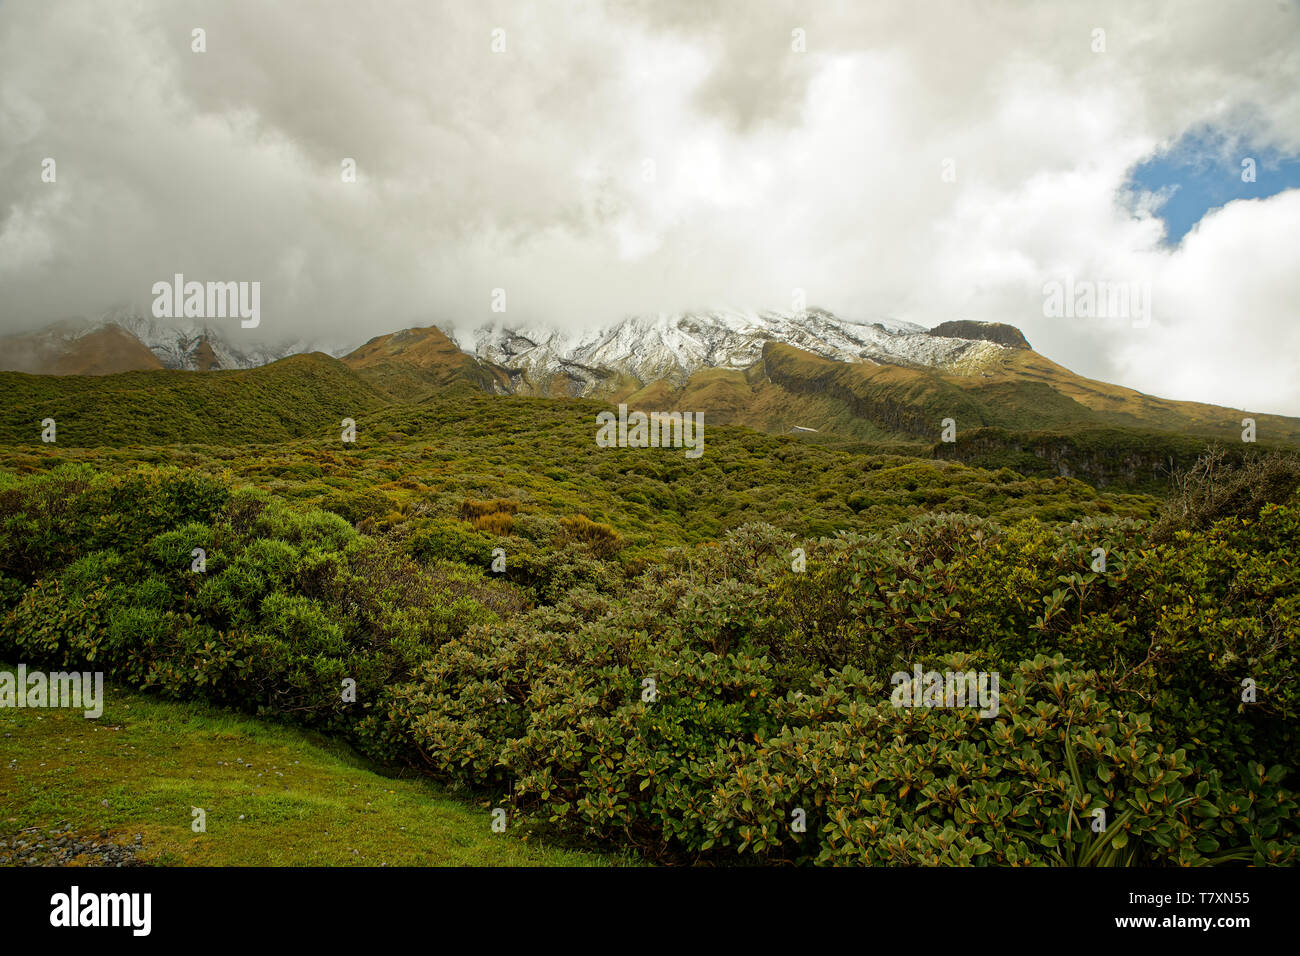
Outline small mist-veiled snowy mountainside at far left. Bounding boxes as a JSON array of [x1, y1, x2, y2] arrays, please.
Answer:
[[96, 306, 346, 371]]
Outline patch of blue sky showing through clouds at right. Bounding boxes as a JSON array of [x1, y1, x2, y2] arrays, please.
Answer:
[[1126, 129, 1300, 246]]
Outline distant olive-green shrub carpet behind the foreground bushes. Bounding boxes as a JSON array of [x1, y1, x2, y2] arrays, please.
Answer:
[[0, 387, 1160, 572]]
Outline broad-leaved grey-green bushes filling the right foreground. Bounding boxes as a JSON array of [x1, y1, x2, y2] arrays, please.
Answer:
[[372, 506, 1300, 865]]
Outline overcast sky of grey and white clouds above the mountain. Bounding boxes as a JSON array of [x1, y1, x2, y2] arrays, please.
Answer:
[[0, 0, 1300, 415]]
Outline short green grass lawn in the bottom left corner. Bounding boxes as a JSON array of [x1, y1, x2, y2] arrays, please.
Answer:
[[0, 669, 625, 866]]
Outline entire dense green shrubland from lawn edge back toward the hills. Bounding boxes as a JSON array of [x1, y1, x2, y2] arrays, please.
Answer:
[[0, 447, 1300, 865]]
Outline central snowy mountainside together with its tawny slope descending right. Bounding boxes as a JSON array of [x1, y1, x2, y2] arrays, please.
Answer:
[[452, 310, 1300, 442]]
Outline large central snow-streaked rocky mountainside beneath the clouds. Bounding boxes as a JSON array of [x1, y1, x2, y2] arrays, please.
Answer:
[[450, 308, 1009, 395]]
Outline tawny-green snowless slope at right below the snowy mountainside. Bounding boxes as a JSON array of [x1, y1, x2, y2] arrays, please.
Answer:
[[611, 343, 1300, 490]]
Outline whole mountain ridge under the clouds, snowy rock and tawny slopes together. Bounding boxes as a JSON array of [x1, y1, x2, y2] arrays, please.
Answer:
[[3, 308, 1300, 470]]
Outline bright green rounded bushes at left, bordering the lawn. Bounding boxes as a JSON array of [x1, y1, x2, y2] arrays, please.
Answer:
[[0, 470, 517, 732]]
